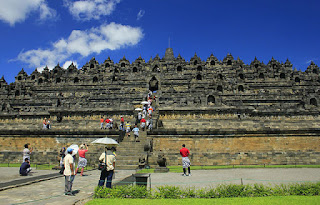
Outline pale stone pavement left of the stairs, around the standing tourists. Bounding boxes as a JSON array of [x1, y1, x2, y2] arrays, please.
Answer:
[[0, 168, 135, 205]]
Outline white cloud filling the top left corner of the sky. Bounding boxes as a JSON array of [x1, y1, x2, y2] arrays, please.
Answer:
[[0, 0, 56, 26]]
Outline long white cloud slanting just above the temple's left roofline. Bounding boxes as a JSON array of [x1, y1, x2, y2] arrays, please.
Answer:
[[16, 22, 143, 67]]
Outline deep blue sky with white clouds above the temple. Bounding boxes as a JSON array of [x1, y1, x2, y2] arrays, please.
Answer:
[[0, 0, 320, 83]]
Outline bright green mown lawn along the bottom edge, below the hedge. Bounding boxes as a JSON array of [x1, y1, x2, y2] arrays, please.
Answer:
[[86, 196, 320, 205]]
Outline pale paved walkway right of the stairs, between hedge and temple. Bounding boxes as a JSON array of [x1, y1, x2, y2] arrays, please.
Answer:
[[148, 166, 320, 188]]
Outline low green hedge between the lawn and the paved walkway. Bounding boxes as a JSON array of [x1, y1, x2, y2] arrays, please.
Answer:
[[94, 182, 320, 199]]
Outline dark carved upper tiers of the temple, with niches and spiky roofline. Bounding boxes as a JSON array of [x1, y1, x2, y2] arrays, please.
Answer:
[[0, 48, 320, 117]]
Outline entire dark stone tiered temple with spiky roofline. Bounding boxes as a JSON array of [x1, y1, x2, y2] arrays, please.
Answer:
[[0, 48, 320, 169]]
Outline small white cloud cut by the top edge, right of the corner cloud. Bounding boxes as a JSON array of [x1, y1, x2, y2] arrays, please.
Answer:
[[64, 0, 121, 21]]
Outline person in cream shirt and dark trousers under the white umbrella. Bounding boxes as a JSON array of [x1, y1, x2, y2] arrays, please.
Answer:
[[98, 147, 116, 188]]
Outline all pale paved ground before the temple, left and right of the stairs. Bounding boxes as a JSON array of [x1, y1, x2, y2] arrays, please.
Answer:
[[0, 168, 320, 205]]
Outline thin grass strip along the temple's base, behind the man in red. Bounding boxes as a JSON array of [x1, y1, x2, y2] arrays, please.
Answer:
[[138, 165, 320, 173]]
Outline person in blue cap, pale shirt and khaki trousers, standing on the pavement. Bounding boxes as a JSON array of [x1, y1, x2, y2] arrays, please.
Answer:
[[63, 147, 75, 196]]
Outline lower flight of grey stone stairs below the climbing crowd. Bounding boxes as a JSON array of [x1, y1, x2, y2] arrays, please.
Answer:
[[116, 129, 147, 169]]
